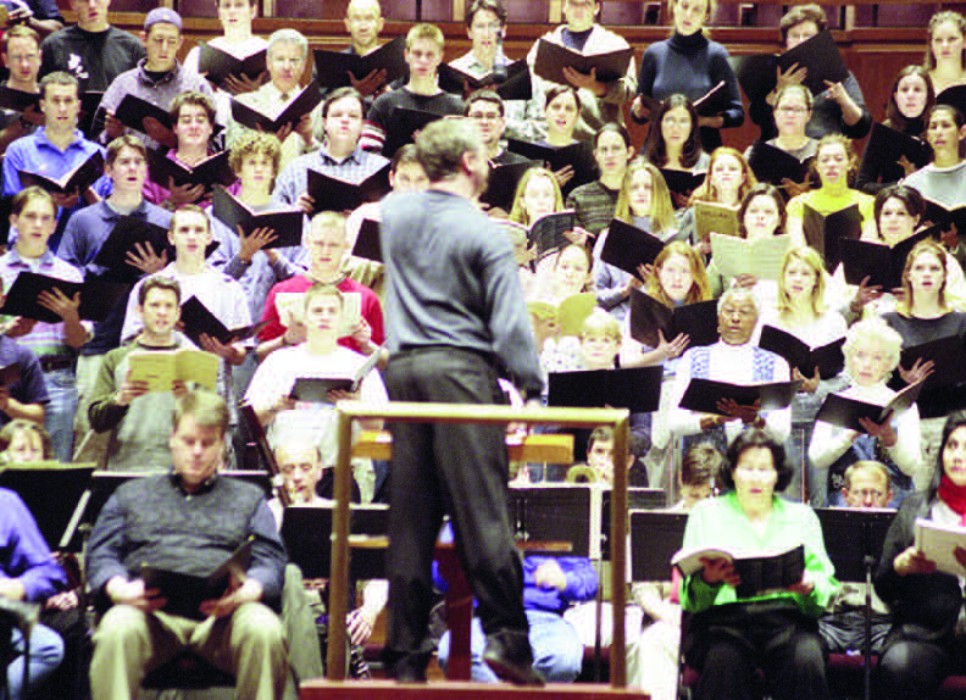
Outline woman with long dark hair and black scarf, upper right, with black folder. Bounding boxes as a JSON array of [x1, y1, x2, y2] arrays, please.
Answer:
[[856, 65, 936, 194]]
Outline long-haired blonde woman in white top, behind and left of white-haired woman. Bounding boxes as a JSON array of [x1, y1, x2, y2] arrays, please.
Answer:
[[761, 247, 847, 505]]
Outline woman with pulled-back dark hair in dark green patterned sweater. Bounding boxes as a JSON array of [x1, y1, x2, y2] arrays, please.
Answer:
[[567, 124, 634, 236]]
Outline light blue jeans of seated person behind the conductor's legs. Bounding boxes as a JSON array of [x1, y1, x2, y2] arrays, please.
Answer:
[[437, 610, 584, 683]]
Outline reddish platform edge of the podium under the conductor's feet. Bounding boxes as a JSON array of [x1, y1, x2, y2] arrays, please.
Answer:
[[299, 680, 649, 700]]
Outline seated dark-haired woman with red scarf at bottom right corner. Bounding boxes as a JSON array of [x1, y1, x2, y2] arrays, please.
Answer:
[[873, 412, 966, 700]]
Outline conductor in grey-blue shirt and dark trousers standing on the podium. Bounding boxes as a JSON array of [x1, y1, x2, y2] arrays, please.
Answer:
[[382, 119, 542, 685]]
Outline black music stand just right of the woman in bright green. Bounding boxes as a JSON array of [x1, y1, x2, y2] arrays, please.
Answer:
[[815, 508, 896, 700]]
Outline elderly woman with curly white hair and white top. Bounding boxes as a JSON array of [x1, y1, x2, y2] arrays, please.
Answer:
[[808, 318, 920, 506]]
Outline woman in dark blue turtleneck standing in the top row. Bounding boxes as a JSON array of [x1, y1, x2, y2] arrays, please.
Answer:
[[631, 0, 745, 152]]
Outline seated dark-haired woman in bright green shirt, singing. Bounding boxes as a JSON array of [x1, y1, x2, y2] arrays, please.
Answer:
[[681, 429, 840, 700]]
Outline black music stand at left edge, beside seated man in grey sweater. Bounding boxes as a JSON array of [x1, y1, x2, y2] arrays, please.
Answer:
[[0, 462, 96, 551]]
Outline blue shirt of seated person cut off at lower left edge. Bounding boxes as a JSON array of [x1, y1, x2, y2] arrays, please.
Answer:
[[0, 489, 67, 602]]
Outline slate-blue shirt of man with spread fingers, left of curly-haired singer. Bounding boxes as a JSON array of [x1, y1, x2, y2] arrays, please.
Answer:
[[57, 200, 171, 355]]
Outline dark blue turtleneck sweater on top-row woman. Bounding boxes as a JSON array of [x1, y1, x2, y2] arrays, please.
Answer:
[[637, 32, 745, 153]]
